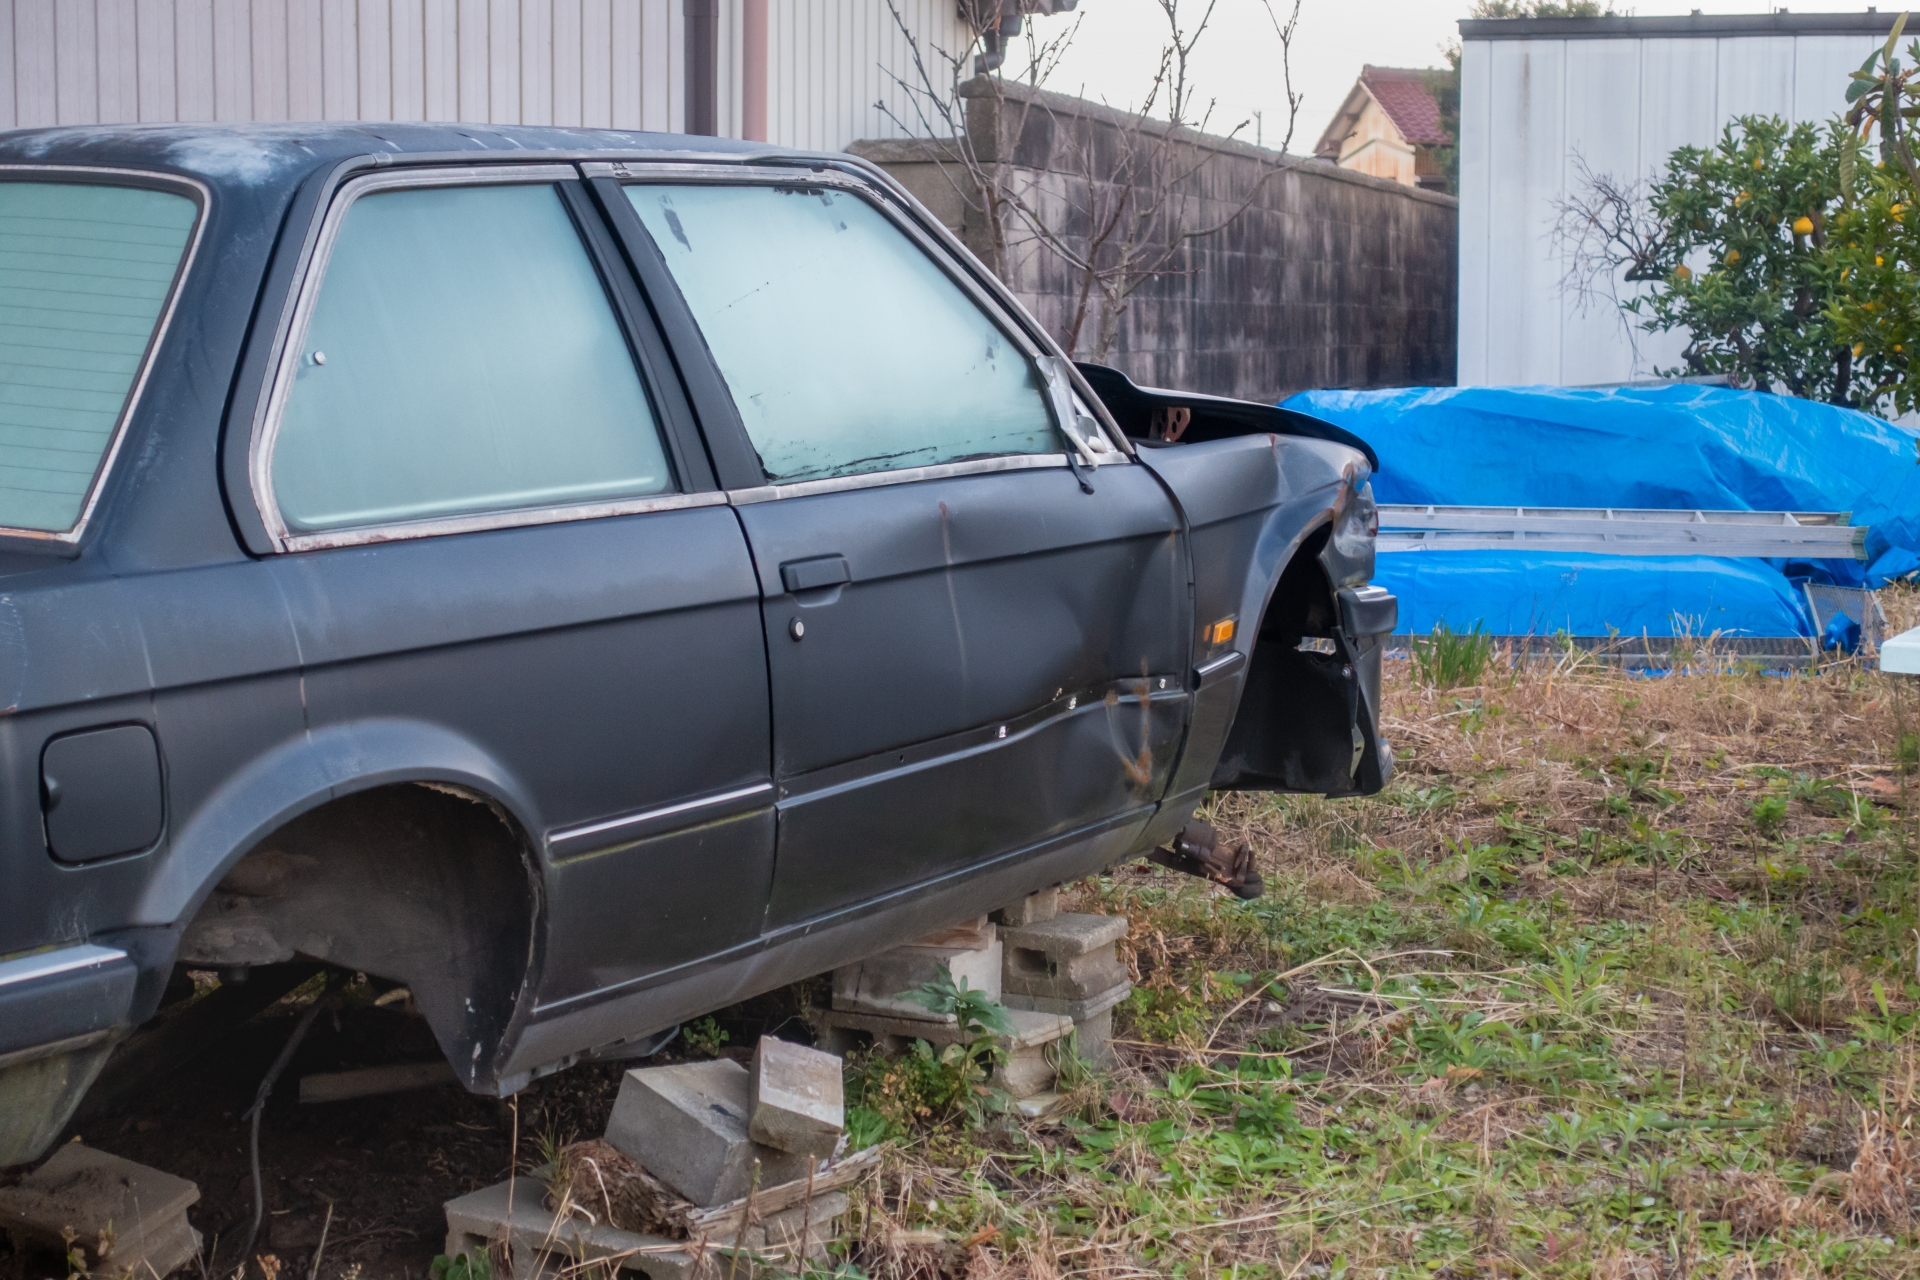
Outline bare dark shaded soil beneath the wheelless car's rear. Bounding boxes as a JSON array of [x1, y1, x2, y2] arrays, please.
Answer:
[[0, 974, 808, 1280]]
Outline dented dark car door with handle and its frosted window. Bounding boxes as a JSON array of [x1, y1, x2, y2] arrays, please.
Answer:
[[611, 171, 1188, 929]]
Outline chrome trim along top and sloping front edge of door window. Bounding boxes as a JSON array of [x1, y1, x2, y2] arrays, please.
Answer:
[[580, 157, 1131, 475]]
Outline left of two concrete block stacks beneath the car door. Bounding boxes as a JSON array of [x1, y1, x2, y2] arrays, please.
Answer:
[[818, 915, 1073, 1100]]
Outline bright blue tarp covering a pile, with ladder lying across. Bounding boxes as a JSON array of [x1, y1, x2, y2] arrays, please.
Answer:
[[1284, 386, 1920, 635]]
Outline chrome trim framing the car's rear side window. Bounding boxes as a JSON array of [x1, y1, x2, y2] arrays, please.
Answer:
[[248, 163, 687, 551]]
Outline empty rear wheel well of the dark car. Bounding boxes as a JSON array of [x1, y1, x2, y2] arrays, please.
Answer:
[[177, 783, 541, 1090]]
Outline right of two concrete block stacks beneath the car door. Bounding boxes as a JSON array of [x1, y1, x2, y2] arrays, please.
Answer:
[[996, 889, 1133, 1067]]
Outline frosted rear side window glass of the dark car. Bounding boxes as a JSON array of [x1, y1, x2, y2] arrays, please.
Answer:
[[271, 184, 672, 532]]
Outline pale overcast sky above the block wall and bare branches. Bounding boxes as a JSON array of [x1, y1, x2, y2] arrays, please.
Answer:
[[1008, 0, 1893, 154]]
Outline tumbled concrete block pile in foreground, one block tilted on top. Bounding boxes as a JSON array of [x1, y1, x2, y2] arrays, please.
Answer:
[[447, 1036, 847, 1280]]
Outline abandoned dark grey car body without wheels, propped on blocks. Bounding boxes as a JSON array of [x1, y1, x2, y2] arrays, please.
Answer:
[[0, 125, 1394, 1163]]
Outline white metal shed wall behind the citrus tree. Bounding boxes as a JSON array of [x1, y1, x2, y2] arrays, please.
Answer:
[[1459, 35, 1885, 386]]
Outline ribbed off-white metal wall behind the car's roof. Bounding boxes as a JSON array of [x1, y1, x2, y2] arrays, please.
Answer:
[[0, 0, 966, 150]]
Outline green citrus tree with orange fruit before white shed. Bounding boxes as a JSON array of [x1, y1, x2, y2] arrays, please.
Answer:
[[1553, 15, 1920, 413]]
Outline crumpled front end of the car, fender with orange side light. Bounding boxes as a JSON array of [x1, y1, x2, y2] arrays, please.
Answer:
[[1081, 365, 1398, 829]]
